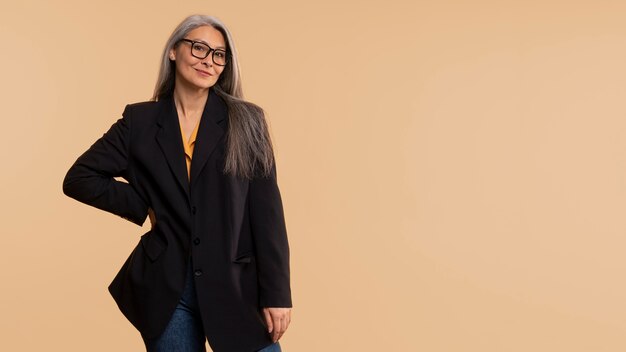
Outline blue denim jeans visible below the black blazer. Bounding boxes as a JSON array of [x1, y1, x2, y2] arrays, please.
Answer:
[[142, 258, 281, 352]]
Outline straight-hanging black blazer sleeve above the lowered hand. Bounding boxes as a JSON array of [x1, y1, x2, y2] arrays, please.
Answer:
[[248, 162, 292, 307]]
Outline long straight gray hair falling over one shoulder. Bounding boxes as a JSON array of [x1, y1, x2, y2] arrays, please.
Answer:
[[152, 15, 274, 179]]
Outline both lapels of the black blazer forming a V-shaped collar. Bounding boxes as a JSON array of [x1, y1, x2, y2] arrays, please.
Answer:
[[156, 88, 228, 197]]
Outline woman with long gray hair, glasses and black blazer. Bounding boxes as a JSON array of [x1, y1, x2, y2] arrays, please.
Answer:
[[63, 15, 292, 352]]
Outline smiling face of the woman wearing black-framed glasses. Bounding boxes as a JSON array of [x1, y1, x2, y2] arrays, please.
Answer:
[[169, 26, 226, 90]]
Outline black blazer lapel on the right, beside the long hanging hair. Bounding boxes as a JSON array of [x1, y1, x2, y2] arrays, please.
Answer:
[[190, 88, 228, 187]]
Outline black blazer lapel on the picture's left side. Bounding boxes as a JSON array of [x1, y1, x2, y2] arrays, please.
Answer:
[[156, 97, 189, 198]]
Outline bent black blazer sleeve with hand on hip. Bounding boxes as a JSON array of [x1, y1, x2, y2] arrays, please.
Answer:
[[63, 105, 148, 226]]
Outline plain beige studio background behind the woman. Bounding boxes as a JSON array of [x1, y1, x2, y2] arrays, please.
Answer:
[[0, 0, 626, 352]]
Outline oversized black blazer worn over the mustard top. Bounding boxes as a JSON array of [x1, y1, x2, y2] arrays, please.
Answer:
[[63, 88, 292, 352]]
